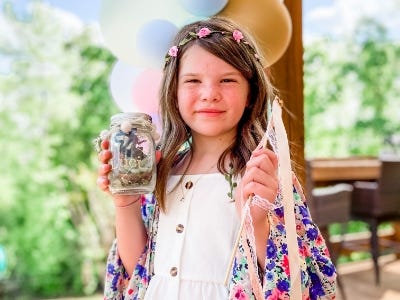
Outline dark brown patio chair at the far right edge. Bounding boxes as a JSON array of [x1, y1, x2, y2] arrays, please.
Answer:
[[351, 159, 400, 285]]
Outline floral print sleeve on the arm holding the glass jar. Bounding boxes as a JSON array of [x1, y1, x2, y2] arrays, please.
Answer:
[[104, 195, 157, 300]]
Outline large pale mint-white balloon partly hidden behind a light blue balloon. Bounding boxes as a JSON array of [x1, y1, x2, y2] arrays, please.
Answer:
[[99, 0, 191, 68]]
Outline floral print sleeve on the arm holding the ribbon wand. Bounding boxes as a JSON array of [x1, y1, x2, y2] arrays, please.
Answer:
[[229, 178, 336, 300]]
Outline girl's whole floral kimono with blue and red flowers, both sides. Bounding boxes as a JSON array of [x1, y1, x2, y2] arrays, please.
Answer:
[[104, 172, 336, 300]]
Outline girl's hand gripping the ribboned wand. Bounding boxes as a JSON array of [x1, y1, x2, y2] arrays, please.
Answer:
[[236, 148, 279, 222]]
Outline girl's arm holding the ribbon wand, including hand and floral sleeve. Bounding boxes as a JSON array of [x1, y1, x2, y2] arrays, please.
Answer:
[[231, 149, 336, 299]]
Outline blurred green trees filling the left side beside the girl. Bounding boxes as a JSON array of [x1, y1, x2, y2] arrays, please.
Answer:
[[0, 2, 116, 298]]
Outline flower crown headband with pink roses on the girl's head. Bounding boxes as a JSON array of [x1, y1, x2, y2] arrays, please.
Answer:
[[165, 27, 260, 65]]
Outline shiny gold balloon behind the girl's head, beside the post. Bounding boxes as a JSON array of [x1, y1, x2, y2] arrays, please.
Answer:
[[218, 0, 292, 66]]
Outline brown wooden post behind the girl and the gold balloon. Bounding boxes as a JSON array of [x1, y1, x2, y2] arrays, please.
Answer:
[[271, 0, 305, 186]]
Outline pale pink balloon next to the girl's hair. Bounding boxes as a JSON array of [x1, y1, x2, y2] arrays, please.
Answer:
[[133, 69, 163, 115]]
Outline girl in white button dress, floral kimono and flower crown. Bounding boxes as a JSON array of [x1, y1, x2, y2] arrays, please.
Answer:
[[98, 17, 336, 300]]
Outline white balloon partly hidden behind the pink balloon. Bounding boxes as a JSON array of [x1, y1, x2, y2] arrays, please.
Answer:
[[109, 61, 141, 112]]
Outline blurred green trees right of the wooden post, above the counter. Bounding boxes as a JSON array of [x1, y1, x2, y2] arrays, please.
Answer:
[[304, 19, 400, 157]]
